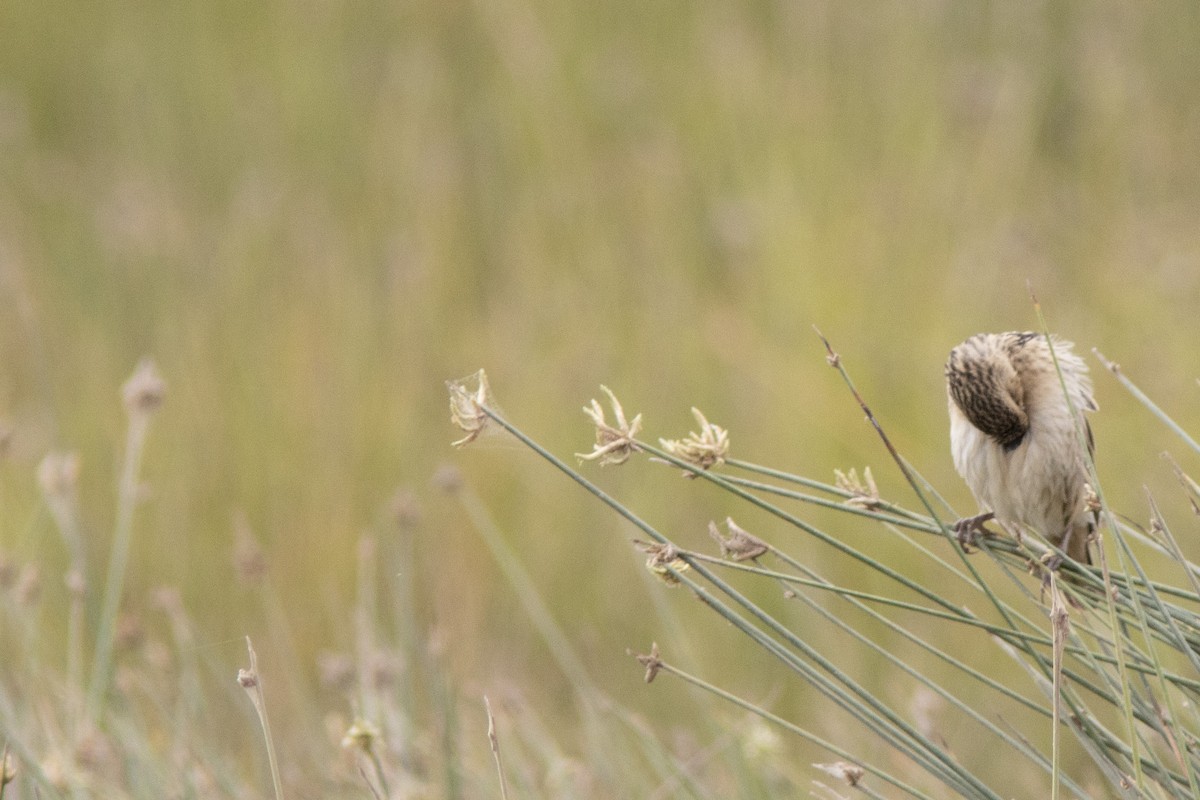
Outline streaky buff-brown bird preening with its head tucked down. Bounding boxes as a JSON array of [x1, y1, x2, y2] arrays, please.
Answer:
[[946, 332, 1097, 564]]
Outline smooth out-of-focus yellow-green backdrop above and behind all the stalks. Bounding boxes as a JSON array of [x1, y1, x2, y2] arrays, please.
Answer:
[[0, 0, 1200, 796]]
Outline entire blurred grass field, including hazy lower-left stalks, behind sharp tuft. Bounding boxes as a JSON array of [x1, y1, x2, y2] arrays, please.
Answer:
[[0, 0, 1200, 800]]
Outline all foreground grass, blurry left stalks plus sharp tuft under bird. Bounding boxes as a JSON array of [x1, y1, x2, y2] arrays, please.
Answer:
[[0, 331, 1200, 799]]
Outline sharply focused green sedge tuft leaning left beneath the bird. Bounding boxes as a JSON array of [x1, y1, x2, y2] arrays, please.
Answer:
[[450, 345, 1200, 800]]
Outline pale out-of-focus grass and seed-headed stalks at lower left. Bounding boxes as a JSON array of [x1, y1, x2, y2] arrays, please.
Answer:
[[0, 365, 772, 800]]
